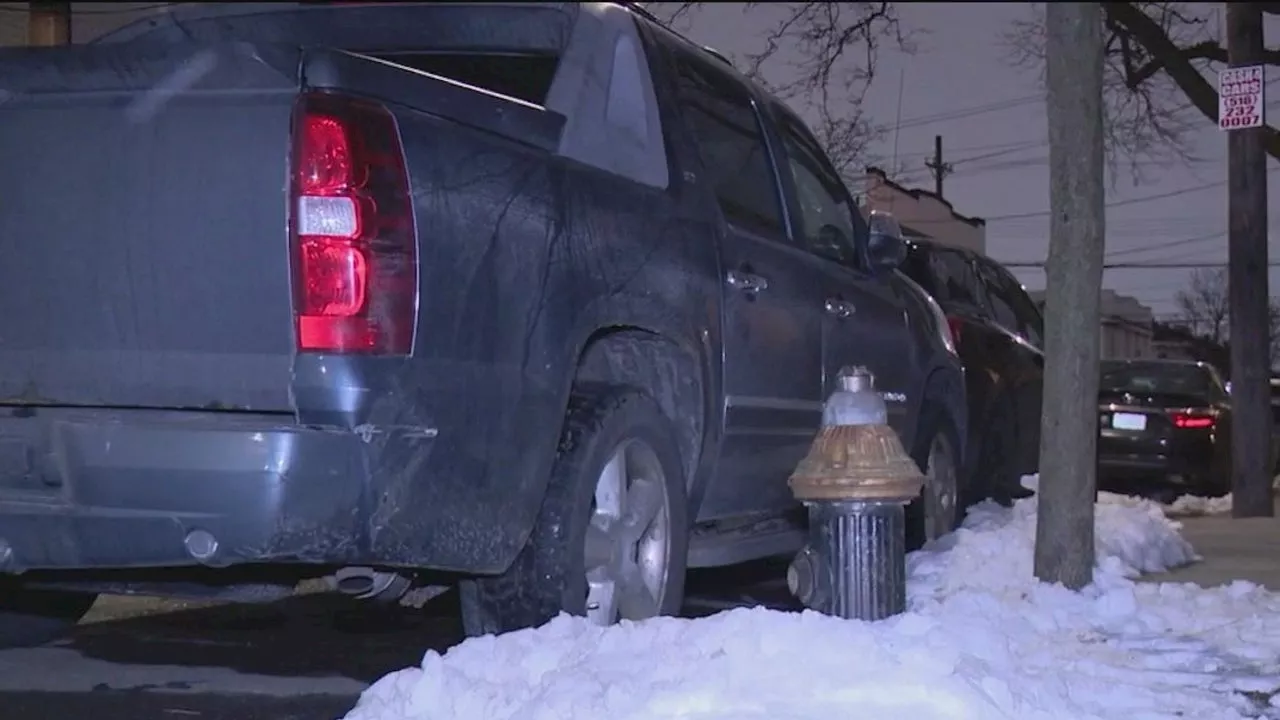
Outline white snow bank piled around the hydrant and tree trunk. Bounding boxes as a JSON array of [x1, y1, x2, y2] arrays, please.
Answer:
[[347, 476, 1280, 720]]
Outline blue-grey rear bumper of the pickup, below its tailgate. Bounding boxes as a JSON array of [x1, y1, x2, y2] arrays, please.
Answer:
[[0, 410, 369, 573]]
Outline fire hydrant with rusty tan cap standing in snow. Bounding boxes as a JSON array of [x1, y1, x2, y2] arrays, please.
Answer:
[[787, 368, 925, 620]]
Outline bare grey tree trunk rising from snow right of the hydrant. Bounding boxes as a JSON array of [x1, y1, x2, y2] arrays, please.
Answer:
[[1036, 3, 1106, 589]]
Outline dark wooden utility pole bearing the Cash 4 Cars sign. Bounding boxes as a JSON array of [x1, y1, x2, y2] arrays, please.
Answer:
[[1219, 3, 1275, 518]]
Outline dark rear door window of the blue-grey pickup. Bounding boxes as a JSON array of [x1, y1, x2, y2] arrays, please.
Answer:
[[676, 53, 783, 236]]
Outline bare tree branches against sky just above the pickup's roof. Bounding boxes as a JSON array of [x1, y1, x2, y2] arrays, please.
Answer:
[[645, 3, 914, 176]]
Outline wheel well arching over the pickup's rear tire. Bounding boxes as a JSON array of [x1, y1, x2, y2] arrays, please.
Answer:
[[573, 327, 705, 484]]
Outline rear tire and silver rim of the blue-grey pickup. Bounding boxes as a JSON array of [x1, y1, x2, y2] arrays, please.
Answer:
[[460, 387, 689, 637]]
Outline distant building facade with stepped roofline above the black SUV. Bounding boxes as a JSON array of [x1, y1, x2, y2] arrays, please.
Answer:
[[859, 168, 987, 255]]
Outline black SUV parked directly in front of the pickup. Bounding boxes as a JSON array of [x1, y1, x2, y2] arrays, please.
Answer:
[[901, 241, 1044, 503]]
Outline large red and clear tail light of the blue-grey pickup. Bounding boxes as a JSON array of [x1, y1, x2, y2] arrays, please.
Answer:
[[292, 94, 417, 355]]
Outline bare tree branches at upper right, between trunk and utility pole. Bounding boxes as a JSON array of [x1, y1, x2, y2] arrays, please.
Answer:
[[1005, 3, 1280, 166]]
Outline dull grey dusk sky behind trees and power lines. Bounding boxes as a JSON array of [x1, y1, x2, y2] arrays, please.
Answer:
[[670, 3, 1280, 318]]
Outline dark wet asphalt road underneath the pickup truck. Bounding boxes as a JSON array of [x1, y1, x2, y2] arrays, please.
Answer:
[[0, 565, 790, 720]]
